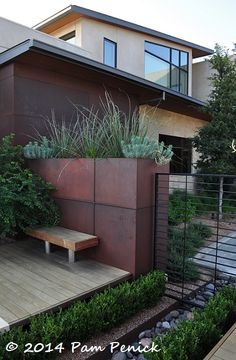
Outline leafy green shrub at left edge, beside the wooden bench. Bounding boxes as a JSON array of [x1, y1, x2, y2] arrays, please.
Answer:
[[0, 135, 59, 236]]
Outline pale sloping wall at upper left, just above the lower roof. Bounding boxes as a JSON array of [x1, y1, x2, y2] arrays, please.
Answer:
[[0, 17, 90, 57]]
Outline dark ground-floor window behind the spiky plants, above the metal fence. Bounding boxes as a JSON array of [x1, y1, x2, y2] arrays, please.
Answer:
[[159, 135, 192, 174]]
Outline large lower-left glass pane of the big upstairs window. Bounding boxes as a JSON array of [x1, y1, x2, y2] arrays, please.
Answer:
[[145, 53, 170, 87]]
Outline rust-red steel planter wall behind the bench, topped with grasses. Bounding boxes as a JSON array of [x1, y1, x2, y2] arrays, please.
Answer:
[[29, 159, 169, 276]]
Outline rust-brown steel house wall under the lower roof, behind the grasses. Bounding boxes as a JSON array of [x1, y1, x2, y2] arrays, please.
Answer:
[[0, 53, 138, 144]]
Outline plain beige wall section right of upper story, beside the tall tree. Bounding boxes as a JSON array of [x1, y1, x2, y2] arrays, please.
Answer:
[[192, 60, 213, 101]]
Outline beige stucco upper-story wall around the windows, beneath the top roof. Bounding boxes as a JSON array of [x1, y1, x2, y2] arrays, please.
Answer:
[[52, 17, 192, 96]]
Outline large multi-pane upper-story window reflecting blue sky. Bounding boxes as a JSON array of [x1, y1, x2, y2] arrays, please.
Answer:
[[145, 41, 188, 95]]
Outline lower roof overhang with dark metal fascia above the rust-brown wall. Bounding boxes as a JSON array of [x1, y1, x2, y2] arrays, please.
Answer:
[[0, 39, 210, 120]]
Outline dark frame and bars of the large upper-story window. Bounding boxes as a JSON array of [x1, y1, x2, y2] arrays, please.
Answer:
[[144, 40, 189, 95]]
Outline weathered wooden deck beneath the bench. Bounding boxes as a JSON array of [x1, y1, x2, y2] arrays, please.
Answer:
[[0, 239, 130, 326]]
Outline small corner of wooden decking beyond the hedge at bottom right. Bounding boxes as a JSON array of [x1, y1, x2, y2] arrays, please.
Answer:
[[204, 323, 236, 360]]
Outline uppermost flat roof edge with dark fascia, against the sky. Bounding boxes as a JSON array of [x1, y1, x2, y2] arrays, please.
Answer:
[[33, 5, 214, 58]]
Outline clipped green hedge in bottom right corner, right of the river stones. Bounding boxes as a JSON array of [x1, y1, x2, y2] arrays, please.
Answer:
[[145, 287, 236, 360]]
